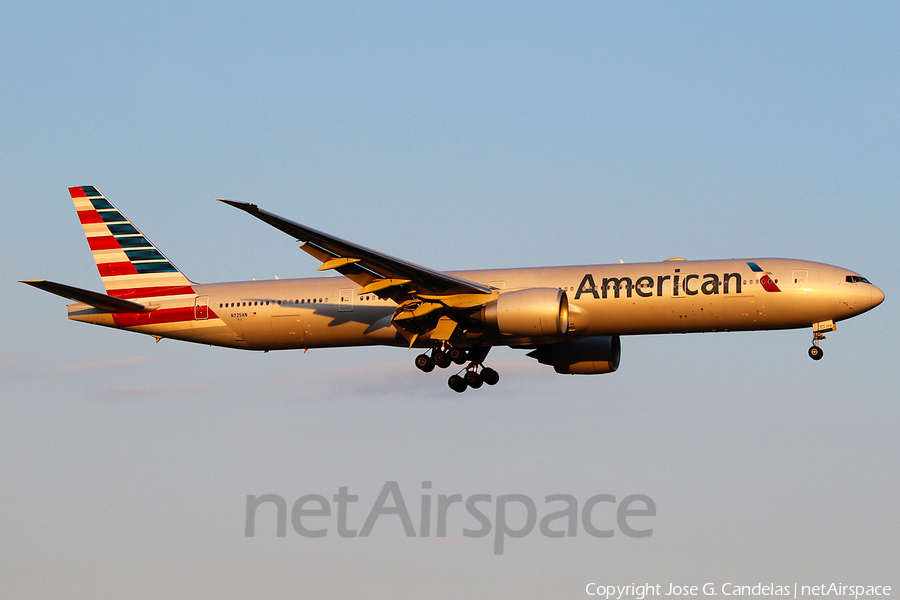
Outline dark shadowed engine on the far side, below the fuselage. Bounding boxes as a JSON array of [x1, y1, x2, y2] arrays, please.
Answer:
[[528, 335, 622, 375]]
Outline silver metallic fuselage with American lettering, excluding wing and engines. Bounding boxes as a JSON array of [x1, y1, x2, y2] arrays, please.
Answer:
[[69, 258, 884, 350]]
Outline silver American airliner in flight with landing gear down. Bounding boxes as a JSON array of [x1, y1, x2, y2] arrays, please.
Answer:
[[22, 185, 884, 392]]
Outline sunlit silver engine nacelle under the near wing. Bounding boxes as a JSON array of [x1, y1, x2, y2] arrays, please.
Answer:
[[481, 288, 569, 336]]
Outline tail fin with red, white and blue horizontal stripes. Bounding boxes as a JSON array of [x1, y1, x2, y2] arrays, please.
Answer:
[[69, 185, 193, 298]]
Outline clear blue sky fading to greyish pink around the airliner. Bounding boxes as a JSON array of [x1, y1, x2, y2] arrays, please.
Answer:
[[0, 2, 900, 598]]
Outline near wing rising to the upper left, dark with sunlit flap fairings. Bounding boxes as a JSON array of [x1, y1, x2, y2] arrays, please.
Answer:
[[218, 198, 491, 297]]
